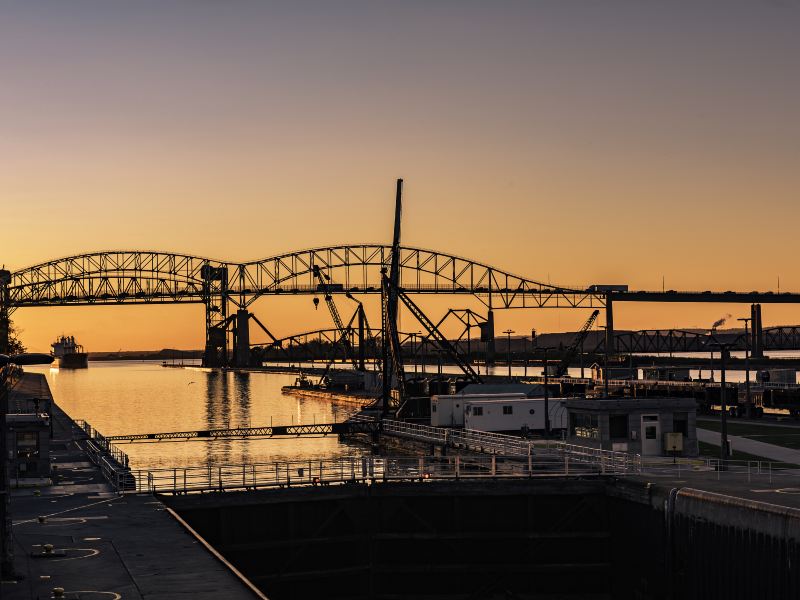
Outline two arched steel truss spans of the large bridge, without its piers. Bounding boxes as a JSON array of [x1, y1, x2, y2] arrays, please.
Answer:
[[9, 244, 604, 308]]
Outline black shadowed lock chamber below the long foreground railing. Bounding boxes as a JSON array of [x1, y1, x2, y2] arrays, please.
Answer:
[[164, 479, 800, 600]]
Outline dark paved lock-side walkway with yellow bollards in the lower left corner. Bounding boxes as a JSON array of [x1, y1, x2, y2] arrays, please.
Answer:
[[0, 376, 259, 600]]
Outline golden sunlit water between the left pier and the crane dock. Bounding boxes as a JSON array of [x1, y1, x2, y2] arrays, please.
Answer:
[[28, 361, 358, 468]]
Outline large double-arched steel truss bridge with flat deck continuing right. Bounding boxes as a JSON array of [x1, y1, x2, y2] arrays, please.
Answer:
[[0, 244, 800, 366]]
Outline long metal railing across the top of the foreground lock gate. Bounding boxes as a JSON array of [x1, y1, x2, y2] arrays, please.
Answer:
[[131, 454, 632, 494]]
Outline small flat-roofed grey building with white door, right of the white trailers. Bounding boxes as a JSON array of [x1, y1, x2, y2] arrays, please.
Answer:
[[566, 398, 699, 456]]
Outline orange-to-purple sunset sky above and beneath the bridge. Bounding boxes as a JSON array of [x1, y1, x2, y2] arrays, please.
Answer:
[[0, 0, 800, 351]]
